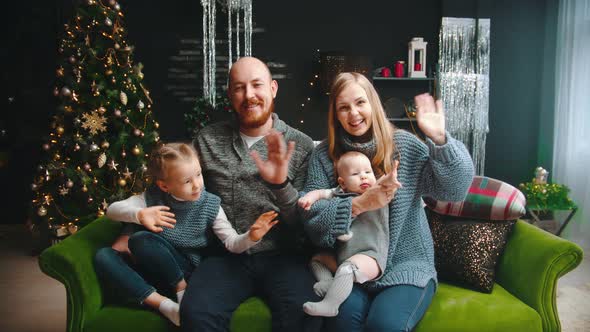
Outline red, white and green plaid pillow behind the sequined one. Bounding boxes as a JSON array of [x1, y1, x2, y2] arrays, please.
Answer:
[[424, 176, 526, 220]]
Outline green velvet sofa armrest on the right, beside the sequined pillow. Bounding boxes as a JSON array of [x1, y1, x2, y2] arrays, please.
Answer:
[[496, 220, 583, 331]]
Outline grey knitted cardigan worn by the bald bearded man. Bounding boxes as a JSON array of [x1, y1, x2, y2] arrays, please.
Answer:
[[194, 113, 313, 253]]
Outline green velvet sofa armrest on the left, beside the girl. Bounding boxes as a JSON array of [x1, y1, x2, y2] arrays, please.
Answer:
[[39, 217, 121, 332]]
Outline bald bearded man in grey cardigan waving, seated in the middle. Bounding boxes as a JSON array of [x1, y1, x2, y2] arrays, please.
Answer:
[[180, 57, 321, 332]]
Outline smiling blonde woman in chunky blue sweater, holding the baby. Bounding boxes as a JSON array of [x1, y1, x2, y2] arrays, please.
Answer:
[[301, 73, 474, 331]]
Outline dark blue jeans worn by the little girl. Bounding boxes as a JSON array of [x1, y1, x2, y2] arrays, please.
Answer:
[[94, 231, 193, 304]]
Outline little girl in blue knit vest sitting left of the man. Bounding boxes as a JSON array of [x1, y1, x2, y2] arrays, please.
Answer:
[[95, 143, 278, 326]]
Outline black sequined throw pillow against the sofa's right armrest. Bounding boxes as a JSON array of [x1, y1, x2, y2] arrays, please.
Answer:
[[426, 209, 516, 293]]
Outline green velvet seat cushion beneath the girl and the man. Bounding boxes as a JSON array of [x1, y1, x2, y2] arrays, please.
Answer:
[[84, 297, 271, 332]]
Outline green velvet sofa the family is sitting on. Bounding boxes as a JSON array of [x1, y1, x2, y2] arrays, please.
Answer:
[[39, 218, 582, 332]]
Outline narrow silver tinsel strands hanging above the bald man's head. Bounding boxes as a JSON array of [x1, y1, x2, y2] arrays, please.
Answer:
[[201, 0, 252, 107]]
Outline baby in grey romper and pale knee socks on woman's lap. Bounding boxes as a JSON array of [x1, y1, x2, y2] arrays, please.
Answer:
[[298, 151, 401, 317]]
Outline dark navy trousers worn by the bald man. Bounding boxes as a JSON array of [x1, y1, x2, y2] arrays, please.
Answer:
[[180, 253, 322, 332]]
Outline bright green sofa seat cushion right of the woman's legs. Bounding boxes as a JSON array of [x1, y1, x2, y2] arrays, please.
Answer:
[[414, 283, 543, 332]]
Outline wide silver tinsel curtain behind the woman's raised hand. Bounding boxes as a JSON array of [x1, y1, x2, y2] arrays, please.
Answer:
[[439, 17, 490, 175]]
